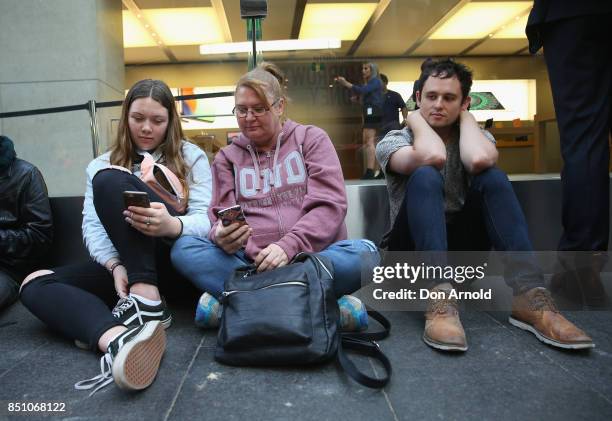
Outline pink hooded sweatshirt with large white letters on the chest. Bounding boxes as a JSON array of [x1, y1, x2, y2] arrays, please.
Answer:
[[208, 120, 347, 260]]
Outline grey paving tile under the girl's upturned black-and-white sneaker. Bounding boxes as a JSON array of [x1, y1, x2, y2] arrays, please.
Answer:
[[0, 309, 202, 420]]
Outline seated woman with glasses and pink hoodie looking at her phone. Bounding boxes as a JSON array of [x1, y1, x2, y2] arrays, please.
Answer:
[[172, 63, 379, 324]]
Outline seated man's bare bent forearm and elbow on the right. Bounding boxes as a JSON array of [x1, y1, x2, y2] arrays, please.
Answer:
[[459, 111, 499, 174]]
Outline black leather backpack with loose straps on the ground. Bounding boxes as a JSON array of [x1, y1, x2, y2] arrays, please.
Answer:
[[215, 253, 391, 388]]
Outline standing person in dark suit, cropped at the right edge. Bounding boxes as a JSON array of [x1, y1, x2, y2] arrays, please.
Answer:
[[526, 0, 612, 307]]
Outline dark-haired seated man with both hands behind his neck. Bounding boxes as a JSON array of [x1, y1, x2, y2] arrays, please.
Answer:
[[376, 59, 594, 351]]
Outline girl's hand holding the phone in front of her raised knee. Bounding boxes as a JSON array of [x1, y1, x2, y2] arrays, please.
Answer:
[[123, 202, 181, 238]]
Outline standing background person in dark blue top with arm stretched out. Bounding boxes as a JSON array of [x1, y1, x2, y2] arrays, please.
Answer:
[[334, 63, 384, 180]]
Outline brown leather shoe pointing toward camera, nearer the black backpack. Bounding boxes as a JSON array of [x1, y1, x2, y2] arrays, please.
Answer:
[[423, 286, 468, 351]]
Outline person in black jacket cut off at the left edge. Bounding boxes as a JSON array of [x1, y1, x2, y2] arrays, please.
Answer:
[[0, 136, 53, 310]]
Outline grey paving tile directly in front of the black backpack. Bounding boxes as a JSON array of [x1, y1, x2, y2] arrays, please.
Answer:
[[170, 335, 393, 420]]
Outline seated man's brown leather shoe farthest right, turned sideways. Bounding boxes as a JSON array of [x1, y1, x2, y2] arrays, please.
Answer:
[[509, 288, 595, 349]]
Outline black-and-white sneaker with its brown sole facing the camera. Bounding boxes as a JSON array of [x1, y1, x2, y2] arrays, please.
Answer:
[[74, 320, 166, 396]]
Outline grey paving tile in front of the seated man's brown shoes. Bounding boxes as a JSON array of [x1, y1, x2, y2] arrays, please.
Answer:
[[384, 318, 612, 420]]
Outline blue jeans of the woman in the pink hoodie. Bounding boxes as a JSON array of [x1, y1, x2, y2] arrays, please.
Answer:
[[171, 236, 380, 298]]
